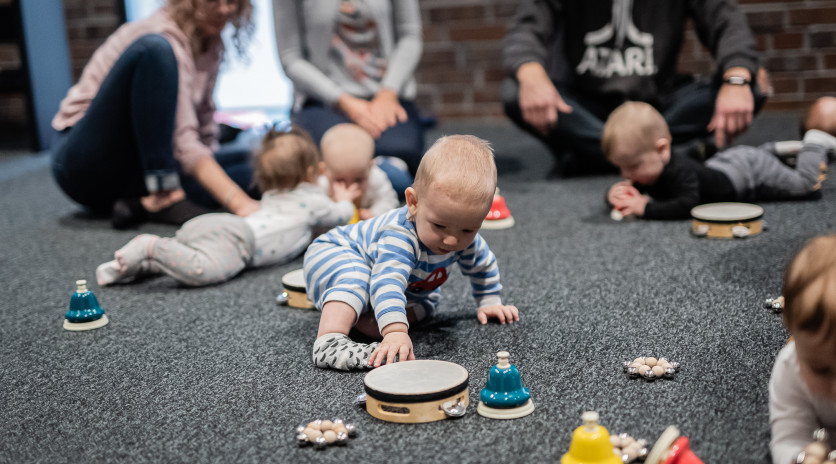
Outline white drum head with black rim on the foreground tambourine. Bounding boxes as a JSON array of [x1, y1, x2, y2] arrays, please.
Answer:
[[364, 359, 470, 403]]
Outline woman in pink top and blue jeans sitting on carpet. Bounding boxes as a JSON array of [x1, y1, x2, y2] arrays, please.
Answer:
[[52, 0, 258, 228]]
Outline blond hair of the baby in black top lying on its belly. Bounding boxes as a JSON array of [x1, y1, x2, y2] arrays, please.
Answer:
[[601, 101, 671, 159]]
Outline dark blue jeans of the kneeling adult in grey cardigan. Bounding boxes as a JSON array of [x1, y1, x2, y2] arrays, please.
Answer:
[[292, 99, 424, 195]]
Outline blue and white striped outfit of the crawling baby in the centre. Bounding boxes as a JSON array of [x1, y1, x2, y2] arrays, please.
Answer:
[[305, 206, 502, 330]]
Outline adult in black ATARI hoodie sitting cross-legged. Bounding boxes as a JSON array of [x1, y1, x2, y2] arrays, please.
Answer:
[[503, 0, 765, 171]]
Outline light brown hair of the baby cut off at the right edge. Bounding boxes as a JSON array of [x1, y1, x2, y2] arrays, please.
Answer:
[[783, 235, 836, 339]]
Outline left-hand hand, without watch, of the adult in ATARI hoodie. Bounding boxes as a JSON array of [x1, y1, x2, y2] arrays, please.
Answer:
[[517, 62, 572, 135]]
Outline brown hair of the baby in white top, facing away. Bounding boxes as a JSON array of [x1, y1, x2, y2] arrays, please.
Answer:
[[254, 125, 319, 192]]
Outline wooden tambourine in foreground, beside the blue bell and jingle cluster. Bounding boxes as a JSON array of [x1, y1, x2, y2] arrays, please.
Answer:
[[364, 359, 470, 424]]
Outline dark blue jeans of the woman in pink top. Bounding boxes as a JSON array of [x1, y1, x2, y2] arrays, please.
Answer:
[[52, 34, 252, 212]]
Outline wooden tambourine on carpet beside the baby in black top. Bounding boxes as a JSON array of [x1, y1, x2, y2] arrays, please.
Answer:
[[691, 203, 763, 238]]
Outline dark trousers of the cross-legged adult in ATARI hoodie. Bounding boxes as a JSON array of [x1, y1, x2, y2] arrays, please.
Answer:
[[502, 78, 766, 172]]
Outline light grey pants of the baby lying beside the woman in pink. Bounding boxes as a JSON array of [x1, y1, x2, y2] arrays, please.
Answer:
[[147, 213, 255, 286]]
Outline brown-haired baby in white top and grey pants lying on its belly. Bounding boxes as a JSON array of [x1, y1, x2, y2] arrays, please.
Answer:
[[96, 127, 362, 286]]
